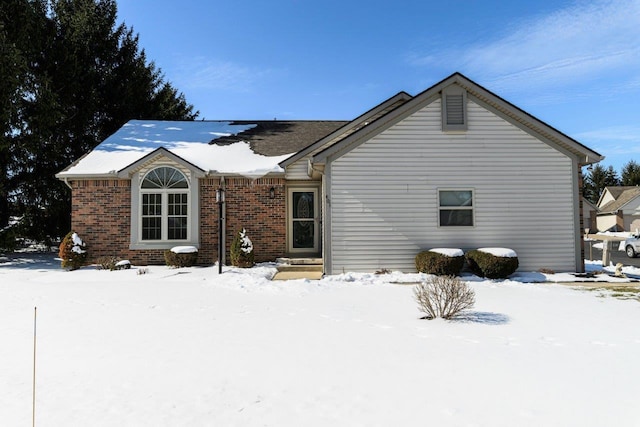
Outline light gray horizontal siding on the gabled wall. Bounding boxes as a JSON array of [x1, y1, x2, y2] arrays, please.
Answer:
[[328, 101, 576, 273]]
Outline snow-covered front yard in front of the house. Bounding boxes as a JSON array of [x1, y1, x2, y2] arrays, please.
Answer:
[[0, 255, 640, 427]]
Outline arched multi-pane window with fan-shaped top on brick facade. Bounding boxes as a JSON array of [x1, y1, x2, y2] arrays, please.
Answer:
[[140, 166, 189, 241]]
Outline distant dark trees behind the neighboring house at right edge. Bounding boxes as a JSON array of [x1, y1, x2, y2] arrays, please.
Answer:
[[582, 160, 640, 204]]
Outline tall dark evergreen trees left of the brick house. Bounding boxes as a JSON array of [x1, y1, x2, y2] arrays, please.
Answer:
[[0, 0, 198, 247]]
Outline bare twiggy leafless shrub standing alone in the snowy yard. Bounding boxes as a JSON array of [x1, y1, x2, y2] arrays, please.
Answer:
[[413, 276, 476, 319]]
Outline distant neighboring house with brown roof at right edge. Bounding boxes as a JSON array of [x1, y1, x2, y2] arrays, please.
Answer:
[[596, 186, 640, 231]]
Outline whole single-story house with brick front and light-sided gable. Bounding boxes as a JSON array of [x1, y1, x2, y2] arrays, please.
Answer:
[[57, 73, 602, 274]]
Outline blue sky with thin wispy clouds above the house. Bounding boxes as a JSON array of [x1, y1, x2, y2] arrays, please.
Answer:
[[118, 0, 640, 172]]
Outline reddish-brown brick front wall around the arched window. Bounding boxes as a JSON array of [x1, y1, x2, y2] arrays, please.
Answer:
[[71, 178, 286, 265]]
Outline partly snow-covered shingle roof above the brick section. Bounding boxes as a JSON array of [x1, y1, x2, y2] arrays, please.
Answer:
[[56, 120, 347, 179]]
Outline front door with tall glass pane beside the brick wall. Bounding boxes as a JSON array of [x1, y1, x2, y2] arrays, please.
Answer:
[[288, 188, 320, 254]]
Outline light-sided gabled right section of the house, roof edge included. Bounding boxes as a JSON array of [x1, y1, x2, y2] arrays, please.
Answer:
[[281, 73, 603, 274]]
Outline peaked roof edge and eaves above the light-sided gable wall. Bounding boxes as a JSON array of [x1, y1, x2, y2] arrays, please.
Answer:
[[313, 72, 604, 165]]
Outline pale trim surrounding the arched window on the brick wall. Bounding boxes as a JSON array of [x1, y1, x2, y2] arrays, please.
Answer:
[[129, 163, 200, 249]]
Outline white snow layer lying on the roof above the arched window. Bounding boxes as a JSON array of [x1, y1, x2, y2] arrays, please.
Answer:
[[58, 120, 293, 178]]
